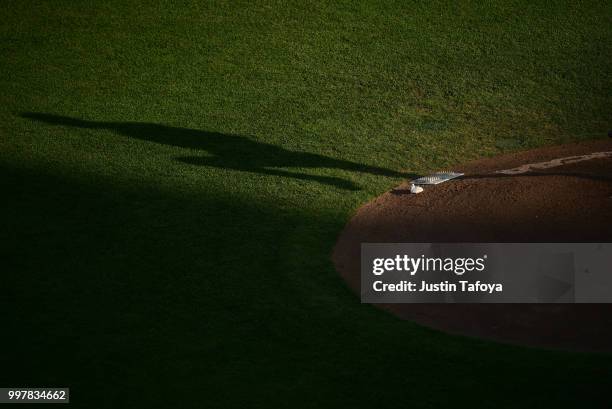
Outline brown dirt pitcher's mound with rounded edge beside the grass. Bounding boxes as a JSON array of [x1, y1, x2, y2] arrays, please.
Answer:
[[333, 139, 612, 351]]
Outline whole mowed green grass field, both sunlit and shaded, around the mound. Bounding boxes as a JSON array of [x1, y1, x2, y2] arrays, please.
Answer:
[[0, 0, 612, 408]]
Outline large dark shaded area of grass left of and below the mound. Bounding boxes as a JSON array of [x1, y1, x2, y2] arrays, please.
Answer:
[[0, 168, 610, 407]]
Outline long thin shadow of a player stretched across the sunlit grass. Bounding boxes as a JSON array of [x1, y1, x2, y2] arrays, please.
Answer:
[[21, 112, 412, 190]]
